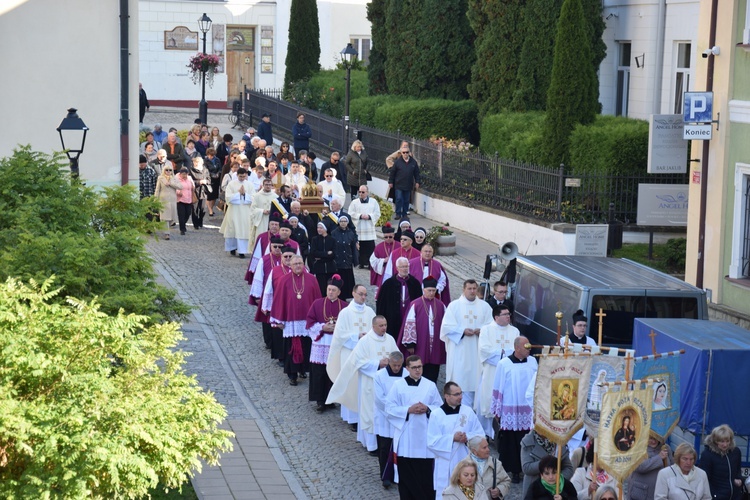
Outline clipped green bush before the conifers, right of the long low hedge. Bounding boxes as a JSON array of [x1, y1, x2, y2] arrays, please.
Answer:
[[479, 111, 544, 163]]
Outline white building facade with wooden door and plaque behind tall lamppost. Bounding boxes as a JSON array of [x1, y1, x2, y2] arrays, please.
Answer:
[[139, 0, 370, 108]]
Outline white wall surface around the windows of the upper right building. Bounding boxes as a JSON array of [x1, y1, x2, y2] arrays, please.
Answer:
[[599, 0, 699, 119]]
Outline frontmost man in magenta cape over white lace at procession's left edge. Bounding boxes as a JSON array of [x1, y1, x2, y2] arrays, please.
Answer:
[[306, 274, 349, 413]]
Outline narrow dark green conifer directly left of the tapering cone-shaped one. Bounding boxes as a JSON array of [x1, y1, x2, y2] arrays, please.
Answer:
[[510, 0, 563, 111]]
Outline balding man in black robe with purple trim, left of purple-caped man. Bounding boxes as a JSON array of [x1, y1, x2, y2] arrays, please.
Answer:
[[375, 258, 422, 340]]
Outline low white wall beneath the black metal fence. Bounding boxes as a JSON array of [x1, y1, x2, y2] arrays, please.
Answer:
[[368, 177, 575, 255]]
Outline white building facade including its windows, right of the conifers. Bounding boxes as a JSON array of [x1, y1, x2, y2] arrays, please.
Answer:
[[599, 0, 701, 120]]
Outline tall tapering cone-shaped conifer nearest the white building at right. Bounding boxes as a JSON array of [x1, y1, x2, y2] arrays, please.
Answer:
[[543, 0, 599, 165]]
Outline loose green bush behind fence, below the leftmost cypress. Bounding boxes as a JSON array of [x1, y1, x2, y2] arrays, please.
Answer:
[[287, 69, 368, 118]]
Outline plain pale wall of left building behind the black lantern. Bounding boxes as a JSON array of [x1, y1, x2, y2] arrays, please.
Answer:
[[0, 0, 138, 185]]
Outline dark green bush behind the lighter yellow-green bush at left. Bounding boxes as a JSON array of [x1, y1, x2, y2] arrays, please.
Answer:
[[0, 146, 190, 322]]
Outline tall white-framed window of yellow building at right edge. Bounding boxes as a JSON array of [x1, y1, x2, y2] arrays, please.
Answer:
[[729, 163, 750, 279]]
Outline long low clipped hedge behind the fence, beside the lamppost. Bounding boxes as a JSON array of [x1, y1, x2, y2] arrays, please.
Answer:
[[352, 96, 479, 144]]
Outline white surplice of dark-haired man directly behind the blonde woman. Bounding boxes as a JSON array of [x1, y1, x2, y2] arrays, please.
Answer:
[[427, 405, 484, 500]]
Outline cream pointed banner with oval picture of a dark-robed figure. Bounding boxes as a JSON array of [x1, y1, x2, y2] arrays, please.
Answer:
[[596, 386, 653, 482]]
